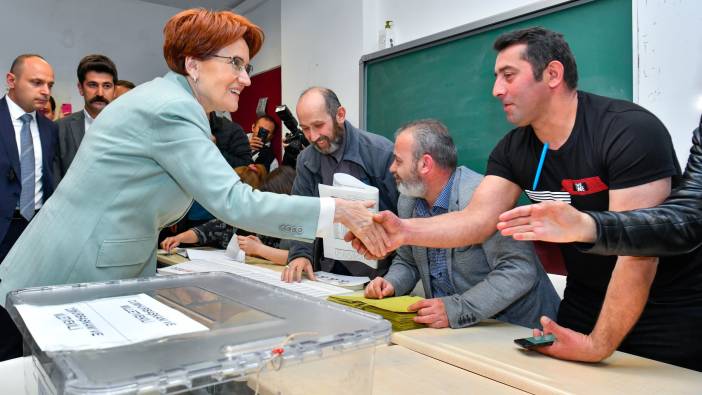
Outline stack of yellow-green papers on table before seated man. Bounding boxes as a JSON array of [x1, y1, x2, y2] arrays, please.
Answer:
[[327, 295, 424, 332]]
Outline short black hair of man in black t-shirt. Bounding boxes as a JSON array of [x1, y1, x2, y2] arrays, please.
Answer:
[[493, 27, 578, 89]]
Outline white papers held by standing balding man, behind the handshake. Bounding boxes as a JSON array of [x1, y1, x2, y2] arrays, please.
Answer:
[[319, 173, 379, 269]]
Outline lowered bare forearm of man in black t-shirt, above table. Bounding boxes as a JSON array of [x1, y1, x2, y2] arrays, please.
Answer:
[[590, 256, 658, 358]]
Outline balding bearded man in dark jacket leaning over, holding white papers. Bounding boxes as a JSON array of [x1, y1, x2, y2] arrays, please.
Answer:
[[282, 87, 398, 282]]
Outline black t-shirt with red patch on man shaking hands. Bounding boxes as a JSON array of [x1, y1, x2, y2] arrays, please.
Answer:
[[487, 92, 680, 333]]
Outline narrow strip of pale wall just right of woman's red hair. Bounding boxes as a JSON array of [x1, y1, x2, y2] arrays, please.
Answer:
[[233, 0, 281, 75]]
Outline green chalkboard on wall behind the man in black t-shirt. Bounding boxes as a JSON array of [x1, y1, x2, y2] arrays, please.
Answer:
[[362, 0, 633, 173]]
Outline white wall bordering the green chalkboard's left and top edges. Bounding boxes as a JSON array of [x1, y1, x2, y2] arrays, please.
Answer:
[[281, 0, 568, 125]]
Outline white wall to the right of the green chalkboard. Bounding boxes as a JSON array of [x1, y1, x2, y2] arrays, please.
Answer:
[[634, 0, 702, 167]]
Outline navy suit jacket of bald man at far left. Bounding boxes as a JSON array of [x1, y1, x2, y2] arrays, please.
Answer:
[[0, 97, 56, 240]]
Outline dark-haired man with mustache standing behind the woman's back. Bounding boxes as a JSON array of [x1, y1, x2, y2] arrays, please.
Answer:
[[54, 54, 117, 184]]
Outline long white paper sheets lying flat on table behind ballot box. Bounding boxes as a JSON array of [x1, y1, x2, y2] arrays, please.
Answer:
[[158, 255, 349, 298]]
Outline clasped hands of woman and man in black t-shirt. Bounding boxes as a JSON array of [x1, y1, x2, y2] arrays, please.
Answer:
[[334, 199, 404, 259]]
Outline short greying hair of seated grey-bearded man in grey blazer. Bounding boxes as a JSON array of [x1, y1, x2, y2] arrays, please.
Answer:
[[395, 119, 458, 170]]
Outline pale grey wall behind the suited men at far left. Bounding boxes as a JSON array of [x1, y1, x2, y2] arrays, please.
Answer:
[[0, 0, 180, 111]]
